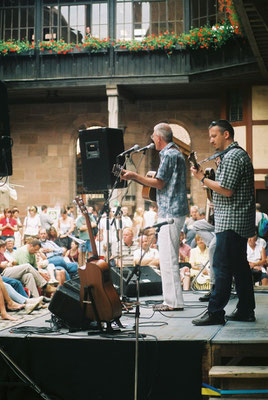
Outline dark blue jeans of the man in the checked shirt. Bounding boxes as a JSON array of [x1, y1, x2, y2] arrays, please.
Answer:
[[208, 230, 255, 317]]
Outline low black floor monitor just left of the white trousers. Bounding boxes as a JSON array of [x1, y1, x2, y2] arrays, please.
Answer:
[[111, 266, 162, 297]]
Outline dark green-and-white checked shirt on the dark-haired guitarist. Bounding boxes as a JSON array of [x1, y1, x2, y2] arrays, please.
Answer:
[[213, 142, 256, 238]]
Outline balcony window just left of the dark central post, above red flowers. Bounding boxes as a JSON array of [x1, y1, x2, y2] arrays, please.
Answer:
[[42, 0, 108, 43]]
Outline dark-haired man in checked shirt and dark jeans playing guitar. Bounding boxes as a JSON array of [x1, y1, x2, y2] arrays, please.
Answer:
[[191, 120, 255, 326]]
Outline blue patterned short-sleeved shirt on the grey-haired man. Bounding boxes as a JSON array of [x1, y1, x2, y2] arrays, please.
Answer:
[[156, 142, 188, 218]]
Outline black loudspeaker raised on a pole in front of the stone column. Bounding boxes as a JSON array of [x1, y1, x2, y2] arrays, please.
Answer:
[[79, 128, 124, 192]]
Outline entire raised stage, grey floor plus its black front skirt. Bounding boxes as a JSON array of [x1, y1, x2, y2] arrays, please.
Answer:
[[0, 291, 268, 400]]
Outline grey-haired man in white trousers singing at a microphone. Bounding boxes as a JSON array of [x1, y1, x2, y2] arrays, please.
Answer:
[[121, 123, 188, 311]]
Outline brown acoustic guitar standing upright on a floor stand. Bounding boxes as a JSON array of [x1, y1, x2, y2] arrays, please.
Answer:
[[75, 196, 122, 326]]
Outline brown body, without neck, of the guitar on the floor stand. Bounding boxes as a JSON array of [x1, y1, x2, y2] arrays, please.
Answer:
[[78, 260, 122, 322]]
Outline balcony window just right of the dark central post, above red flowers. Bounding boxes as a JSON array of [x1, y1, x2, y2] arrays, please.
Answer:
[[116, 0, 183, 40]]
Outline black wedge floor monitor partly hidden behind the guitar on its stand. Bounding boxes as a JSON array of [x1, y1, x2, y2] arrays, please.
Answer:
[[48, 277, 83, 328]]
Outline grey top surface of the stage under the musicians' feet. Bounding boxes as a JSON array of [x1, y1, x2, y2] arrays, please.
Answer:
[[0, 291, 268, 343]]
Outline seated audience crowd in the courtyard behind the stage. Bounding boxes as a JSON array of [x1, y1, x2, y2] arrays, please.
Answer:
[[0, 203, 268, 320]]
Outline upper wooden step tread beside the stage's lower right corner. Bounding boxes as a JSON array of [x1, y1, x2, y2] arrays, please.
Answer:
[[209, 365, 268, 379]]
